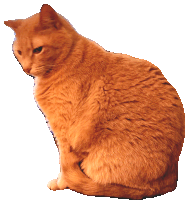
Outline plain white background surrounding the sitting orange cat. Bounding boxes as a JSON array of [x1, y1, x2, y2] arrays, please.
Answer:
[[0, 0, 185, 200]]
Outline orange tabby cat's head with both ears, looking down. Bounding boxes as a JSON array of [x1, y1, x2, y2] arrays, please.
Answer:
[[5, 5, 76, 76]]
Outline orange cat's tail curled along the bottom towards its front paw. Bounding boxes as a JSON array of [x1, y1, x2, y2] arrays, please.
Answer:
[[65, 163, 156, 199]]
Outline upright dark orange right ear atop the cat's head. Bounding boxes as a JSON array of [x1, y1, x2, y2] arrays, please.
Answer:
[[40, 4, 62, 29]]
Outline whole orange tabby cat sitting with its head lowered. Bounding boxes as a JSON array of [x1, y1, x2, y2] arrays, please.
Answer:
[[5, 5, 185, 199]]
